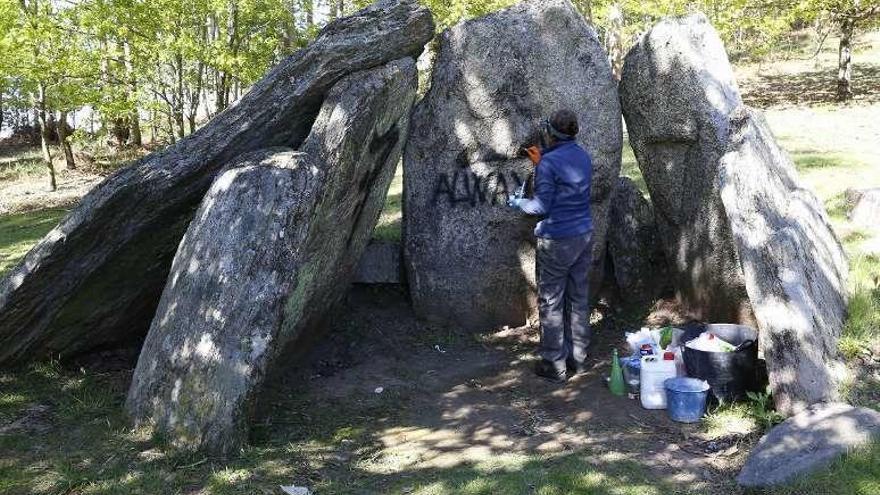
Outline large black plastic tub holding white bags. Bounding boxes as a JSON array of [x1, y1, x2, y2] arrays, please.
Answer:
[[682, 324, 758, 402]]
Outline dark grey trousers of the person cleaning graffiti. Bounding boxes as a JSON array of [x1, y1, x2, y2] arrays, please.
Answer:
[[537, 233, 593, 370]]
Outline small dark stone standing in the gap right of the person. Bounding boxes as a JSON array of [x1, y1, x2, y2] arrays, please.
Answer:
[[607, 177, 669, 303]]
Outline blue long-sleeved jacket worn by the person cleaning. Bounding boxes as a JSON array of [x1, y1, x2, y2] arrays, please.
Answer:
[[519, 140, 593, 239]]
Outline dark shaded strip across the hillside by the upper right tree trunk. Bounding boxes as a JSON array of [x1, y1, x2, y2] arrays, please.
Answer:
[[742, 61, 880, 108]]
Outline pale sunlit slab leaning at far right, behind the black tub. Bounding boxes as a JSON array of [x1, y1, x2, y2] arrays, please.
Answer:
[[719, 107, 849, 413]]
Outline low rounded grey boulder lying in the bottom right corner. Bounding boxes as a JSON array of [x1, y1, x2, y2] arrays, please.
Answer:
[[736, 403, 880, 488]]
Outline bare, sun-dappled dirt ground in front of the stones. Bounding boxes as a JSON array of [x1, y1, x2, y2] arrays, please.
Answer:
[[255, 288, 754, 494]]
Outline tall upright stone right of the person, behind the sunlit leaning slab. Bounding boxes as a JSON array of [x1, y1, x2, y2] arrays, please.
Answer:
[[620, 14, 754, 324]]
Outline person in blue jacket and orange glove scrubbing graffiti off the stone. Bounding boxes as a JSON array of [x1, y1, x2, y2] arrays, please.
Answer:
[[509, 110, 593, 383]]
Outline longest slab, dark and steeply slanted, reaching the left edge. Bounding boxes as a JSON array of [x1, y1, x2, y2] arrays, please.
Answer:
[[0, 0, 434, 364]]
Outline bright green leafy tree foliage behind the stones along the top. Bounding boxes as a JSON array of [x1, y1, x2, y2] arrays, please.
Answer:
[[0, 0, 868, 188]]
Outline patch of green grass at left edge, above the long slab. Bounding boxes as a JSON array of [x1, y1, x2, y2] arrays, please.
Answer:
[[0, 208, 67, 277]]
